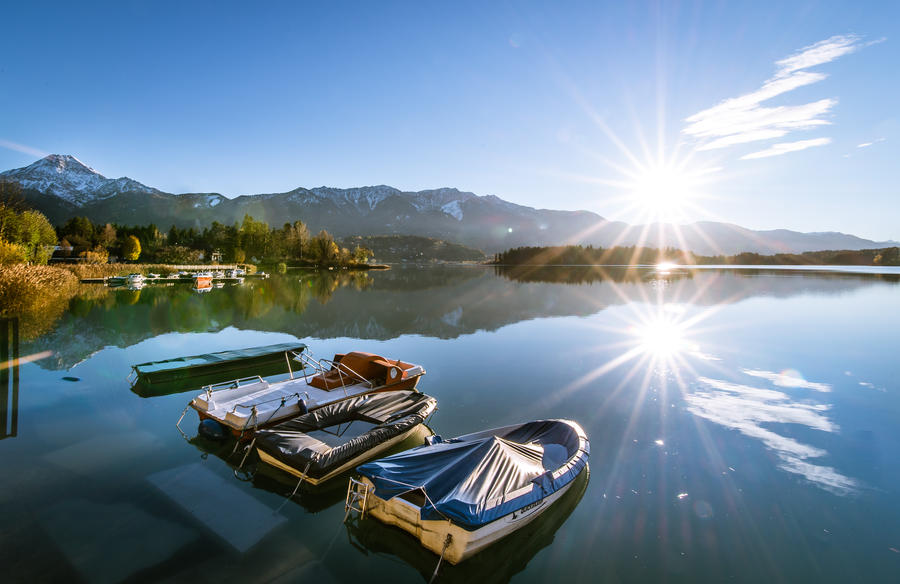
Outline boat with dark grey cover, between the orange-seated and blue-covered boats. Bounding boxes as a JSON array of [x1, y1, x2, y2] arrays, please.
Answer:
[[254, 390, 437, 485]]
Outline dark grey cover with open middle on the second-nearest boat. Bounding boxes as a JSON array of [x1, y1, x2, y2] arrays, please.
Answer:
[[256, 390, 437, 478]]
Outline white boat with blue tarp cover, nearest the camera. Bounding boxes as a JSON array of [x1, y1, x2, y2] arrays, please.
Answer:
[[347, 420, 590, 564]]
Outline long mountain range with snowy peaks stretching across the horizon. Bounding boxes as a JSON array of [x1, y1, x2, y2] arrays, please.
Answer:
[[0, 154, 898, 255]]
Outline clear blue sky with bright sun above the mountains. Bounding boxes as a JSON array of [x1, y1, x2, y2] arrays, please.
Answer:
[[0, 1, 900, 240]]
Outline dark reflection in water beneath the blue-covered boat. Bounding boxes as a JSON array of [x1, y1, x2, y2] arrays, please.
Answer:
[[346, 465, 591, 584]]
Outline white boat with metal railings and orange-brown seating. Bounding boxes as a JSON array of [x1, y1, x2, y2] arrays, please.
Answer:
[[185, 351, 425, 438]]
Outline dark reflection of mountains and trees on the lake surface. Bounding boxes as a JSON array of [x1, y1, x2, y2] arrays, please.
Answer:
[[25, 266, 893, 369]]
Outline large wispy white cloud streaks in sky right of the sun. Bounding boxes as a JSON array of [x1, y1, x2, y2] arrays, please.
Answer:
[[682, 34, 877, 160]]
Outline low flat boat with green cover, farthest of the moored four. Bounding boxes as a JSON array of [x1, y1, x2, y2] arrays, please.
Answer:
[[129, 342, 306, 395]]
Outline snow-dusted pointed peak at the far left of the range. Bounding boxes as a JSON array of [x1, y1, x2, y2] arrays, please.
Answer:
[[0, 154, 160, 206]]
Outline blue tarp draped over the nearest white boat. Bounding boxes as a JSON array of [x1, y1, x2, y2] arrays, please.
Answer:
[[357, 420, 590, 529]]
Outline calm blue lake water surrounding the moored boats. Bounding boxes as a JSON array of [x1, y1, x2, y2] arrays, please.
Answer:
[[0, 266, 900, 583]]
